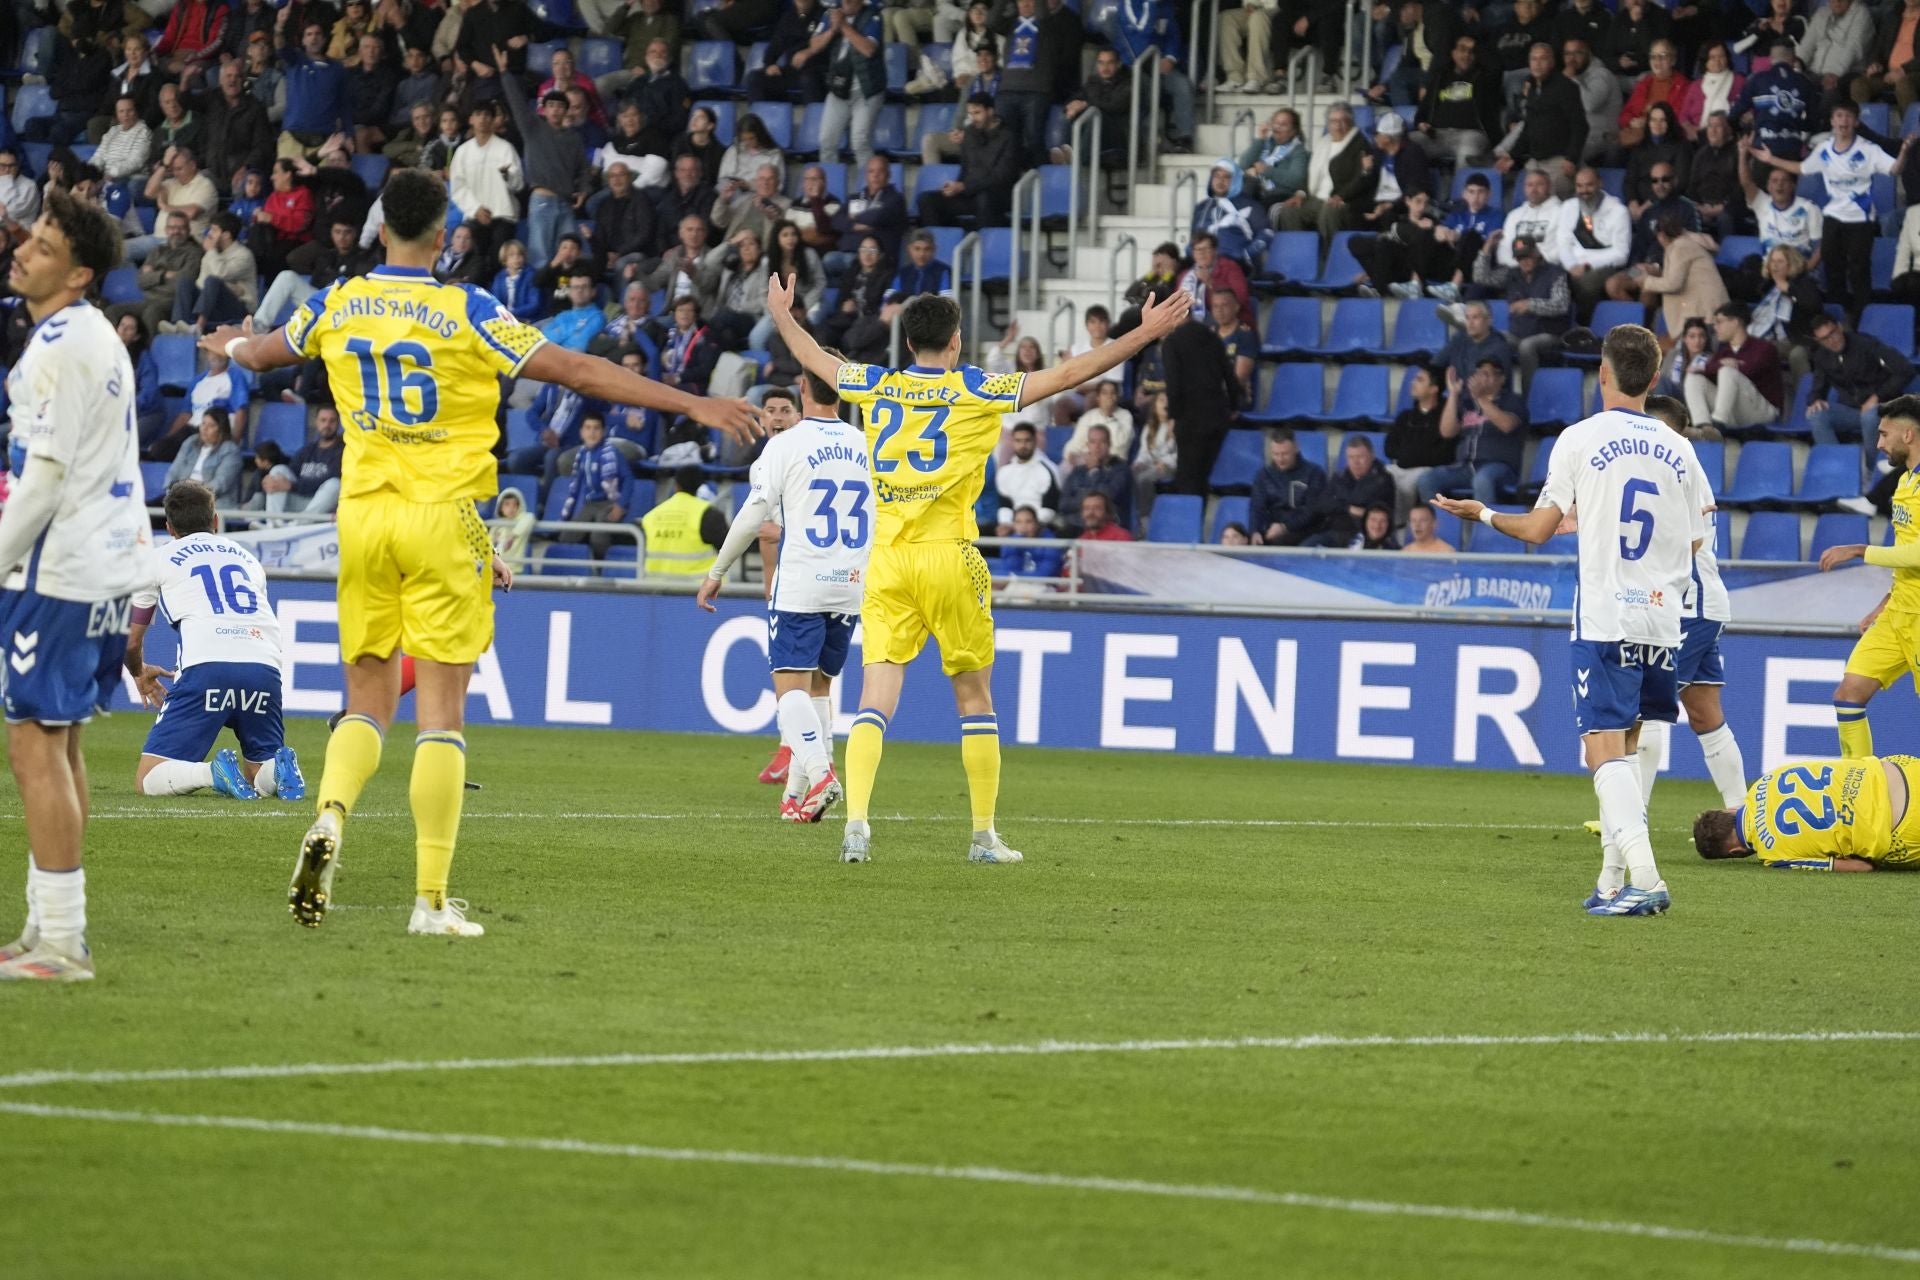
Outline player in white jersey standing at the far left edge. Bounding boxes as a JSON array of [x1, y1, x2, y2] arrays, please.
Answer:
[[0, 192, 154, 983]]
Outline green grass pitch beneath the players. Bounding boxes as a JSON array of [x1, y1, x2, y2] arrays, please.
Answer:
[[0, 716, 1920, 1280]]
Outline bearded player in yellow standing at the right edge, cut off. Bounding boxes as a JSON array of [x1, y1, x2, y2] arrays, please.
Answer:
[[1820, 404, 1920, 756]]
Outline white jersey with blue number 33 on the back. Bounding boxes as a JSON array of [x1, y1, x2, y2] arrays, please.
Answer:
[[751, 410, 874, 614]]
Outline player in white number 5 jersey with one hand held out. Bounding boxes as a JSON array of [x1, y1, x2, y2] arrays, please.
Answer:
[[1434, 324, 1707, 915]]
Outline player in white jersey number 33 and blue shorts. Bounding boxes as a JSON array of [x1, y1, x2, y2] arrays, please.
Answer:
[[697, 353, 874, 821]]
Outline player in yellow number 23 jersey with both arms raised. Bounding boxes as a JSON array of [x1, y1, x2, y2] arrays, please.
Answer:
[[766, 276, 1192, 862]]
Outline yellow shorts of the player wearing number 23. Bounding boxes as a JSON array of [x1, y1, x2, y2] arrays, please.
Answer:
[[860, 541, 993, 676]]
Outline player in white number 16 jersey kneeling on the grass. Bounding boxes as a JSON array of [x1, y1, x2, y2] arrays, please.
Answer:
[[127, 480, 307, 800]]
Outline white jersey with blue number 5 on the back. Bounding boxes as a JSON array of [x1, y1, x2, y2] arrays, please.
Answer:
[[1538, 409, 1707, 649]]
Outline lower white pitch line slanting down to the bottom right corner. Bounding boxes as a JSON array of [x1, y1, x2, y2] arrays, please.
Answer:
[[0, 1102, 1920, 1263]]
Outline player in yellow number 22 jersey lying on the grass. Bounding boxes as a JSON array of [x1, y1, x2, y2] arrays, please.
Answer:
[[1693, 756, 1920, 871]]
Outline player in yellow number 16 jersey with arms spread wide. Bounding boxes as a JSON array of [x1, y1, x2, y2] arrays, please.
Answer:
[[202, 169, 756, 936]]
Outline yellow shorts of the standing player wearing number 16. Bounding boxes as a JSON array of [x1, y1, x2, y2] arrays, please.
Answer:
[[340, 489, 493, 664]]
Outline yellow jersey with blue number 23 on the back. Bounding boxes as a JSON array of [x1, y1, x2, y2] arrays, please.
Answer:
[[837, 363, 1027, 547]]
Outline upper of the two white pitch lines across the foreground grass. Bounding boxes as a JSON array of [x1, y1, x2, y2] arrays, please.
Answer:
[[0, 1031, 1920, 1088]]
